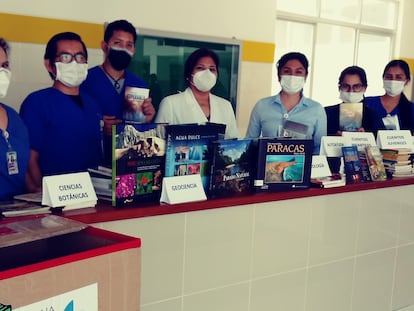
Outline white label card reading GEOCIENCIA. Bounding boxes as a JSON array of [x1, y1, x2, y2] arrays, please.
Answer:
[[160, 174, 207, 204]]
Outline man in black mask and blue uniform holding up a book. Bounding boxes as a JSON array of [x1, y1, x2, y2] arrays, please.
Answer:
[[81, 20, 155, 163]]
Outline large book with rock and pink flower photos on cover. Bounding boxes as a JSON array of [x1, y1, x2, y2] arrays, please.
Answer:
[[112, 122, 166, 207]]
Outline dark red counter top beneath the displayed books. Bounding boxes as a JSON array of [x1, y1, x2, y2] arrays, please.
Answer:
[[63, 178, 414, 224]]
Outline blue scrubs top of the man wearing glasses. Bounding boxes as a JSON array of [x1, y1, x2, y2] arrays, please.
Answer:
[[20, 87, 102, 176]]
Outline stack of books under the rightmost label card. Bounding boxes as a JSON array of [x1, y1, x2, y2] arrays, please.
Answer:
[[381, 148, 414, 177]]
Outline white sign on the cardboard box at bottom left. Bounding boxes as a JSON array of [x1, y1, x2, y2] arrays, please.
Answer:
[[13, 283, 98, 311]]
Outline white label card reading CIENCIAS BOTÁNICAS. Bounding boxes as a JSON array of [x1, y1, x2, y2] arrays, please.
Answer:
[[42, 172, 97, 209]]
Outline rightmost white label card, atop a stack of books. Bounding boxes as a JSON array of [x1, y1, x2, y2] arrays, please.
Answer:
[[377, 130, 414, 152]]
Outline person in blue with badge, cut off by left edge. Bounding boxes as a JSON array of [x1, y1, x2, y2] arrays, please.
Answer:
[[0, 38, 30, 201]]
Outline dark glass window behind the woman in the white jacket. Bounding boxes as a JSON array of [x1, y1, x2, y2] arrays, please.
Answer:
[[129, 29, 241, 111]]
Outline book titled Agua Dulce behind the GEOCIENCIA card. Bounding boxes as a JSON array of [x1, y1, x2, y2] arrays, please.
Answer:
[[165, 122, 226, 194]]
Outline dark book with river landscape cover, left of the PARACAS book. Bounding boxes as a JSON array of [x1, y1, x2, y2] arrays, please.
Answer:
[[210, 139, 257, 198]]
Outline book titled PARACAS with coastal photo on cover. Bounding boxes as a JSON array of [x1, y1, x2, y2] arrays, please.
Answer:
[[254, 138, 313, 192]]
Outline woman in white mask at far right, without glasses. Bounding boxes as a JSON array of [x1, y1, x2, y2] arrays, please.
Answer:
[[365, 59, 414, 135]]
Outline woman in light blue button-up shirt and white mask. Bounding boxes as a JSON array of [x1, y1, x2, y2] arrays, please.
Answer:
[[246, 52, 326, 154]]
